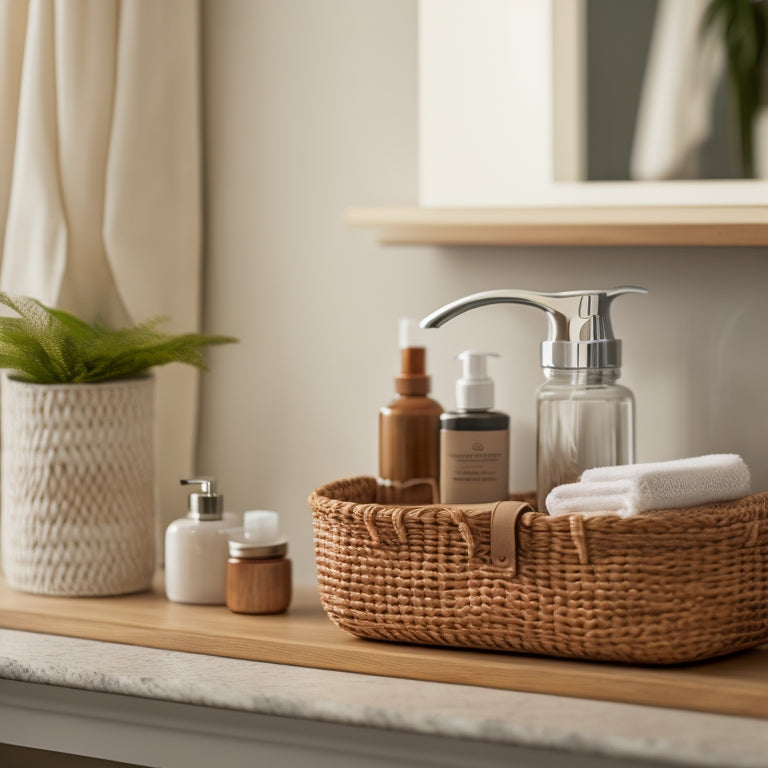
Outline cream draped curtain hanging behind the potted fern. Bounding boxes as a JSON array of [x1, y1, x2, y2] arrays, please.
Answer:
[[0, 0, 201, 552]]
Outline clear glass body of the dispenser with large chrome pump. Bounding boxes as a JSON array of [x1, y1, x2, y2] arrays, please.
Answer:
[[536, 368, 635, 510]]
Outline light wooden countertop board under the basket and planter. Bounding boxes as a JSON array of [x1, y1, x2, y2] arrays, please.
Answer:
[[0, 574, 768, 718]]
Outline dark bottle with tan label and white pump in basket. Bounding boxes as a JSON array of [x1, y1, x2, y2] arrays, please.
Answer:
[[440, 349, 509, 504]]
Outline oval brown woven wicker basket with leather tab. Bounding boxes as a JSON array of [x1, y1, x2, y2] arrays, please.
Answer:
[[310, 477, 768, 664]]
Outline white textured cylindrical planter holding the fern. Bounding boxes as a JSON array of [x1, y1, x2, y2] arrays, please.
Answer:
[[0, 376, 155, 596]]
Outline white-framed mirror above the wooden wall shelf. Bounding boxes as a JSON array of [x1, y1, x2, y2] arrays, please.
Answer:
[[418, 0, 768, 207]]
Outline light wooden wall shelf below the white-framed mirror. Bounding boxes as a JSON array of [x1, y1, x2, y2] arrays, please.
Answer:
[[346, 204, 768, 246]]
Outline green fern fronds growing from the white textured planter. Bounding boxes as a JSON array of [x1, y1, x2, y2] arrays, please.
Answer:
[[0, 291, 237, 384]]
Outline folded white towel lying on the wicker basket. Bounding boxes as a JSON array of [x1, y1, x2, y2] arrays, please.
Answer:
[[546, 453, 750, 517]]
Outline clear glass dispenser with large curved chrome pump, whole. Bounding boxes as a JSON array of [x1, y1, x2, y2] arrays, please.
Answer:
[[421, 286, 648, 511]]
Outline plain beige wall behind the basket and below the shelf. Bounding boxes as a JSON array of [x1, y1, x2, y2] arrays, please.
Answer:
[[200, 0, 768, 581]]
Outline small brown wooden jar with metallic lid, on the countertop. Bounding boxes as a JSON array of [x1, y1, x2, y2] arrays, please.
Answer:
[[227, 513, 292, 614]]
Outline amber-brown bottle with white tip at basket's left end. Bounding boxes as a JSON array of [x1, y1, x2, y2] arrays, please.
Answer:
[[376, 320, 443, 504]]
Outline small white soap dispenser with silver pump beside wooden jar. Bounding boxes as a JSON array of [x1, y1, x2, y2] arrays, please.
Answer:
[[165, 478, 237, 605]]
